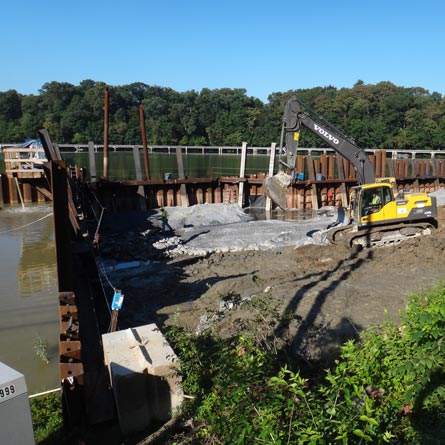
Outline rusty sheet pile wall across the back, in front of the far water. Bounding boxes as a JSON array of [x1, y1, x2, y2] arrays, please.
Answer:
[[2, 142, 445, 211]]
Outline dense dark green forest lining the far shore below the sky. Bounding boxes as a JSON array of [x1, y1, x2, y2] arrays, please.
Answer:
[[0, 80, 445, 149]]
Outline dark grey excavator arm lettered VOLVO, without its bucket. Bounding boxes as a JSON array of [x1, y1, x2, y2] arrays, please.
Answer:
[[283, 96, 376, 184]]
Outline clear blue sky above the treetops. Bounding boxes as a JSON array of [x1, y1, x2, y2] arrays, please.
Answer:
[[0, 0, 445, 102]]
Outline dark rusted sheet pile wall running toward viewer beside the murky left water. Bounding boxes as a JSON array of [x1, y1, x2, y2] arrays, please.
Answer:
[[39, 130, 115, 431]]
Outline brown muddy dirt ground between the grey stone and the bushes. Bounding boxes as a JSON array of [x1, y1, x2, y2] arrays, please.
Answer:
[[102, 206, 445, 360]]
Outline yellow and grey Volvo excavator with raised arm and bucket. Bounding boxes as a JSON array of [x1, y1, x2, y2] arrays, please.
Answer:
[[264, 97, 437, 247]]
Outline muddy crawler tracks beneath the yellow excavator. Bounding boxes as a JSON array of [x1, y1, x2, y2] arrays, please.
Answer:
[[327, 222, 435, 247]]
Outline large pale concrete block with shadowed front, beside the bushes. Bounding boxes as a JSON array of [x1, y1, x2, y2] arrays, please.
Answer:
[[102, 324, 183, 433]]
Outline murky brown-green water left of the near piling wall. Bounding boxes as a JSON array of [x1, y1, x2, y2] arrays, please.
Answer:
[[0, 204, 59, 394]]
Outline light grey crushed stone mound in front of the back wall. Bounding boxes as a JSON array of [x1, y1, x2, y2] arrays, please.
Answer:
[[149, 204, 347, 258]]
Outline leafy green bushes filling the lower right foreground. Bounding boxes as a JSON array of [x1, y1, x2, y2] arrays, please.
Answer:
[[166, 285, 445, 445]]
